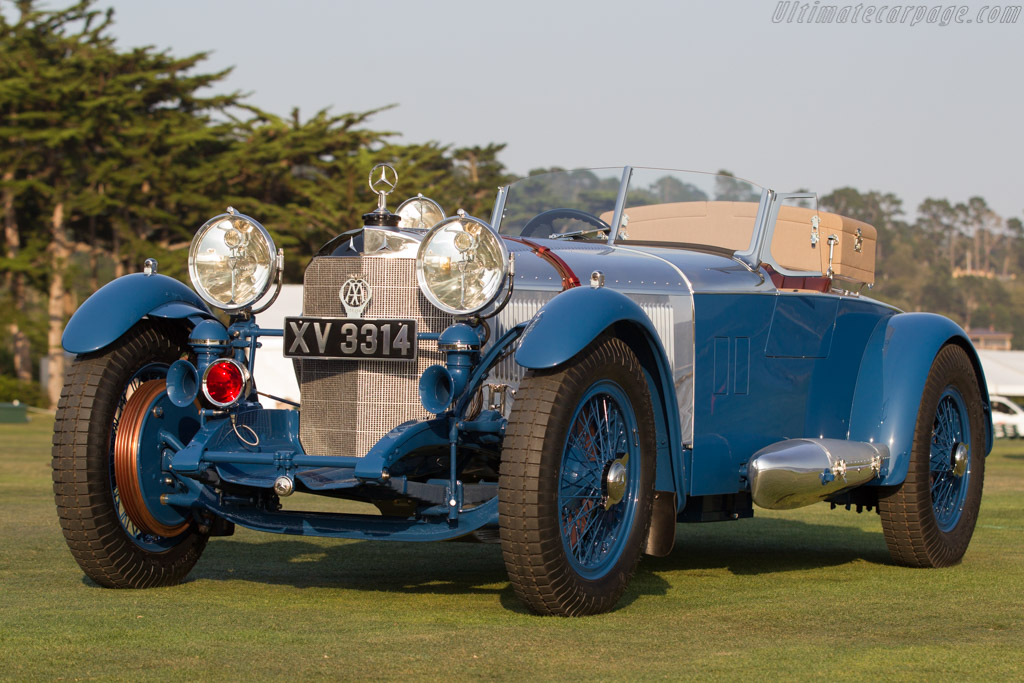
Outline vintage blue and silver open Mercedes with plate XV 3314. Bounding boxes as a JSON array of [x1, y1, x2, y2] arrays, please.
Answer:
[[53, 165, 992, 615]]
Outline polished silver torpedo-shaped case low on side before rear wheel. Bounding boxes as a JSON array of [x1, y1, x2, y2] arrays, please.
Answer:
[[746, 438, 889, 510]]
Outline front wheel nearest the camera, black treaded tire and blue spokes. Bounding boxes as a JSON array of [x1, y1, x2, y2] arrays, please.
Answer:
[[499, 339, 655, 616]]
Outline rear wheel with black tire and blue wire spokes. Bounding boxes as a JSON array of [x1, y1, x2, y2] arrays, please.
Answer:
[[879, 344, 985, 567]]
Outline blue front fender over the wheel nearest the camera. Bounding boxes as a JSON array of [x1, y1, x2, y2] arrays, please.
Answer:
[[515, 287, 686, 509]]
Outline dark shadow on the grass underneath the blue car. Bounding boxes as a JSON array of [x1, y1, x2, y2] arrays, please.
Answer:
[[176, 519, 889, 612]]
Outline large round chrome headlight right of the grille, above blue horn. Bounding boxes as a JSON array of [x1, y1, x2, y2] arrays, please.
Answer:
[[416, 210, 509, 315]]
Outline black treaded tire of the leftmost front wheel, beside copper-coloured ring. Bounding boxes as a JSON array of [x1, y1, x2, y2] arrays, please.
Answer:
[[52, 319, 208, 588]]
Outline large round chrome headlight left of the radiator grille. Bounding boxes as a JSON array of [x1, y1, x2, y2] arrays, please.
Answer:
[[188, 207, 278, 311]]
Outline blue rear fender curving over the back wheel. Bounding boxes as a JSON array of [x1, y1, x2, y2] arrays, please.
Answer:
[[850, 313, 992, 485]]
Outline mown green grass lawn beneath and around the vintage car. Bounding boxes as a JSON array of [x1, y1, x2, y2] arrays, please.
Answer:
[[0, 418, 1024, 681]]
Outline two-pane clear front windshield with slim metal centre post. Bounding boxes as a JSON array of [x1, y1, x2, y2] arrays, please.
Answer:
[[491, 168, 763, 251]]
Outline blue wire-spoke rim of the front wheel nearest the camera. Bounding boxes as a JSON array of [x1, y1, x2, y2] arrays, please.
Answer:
[[558, 380, 640, 580]]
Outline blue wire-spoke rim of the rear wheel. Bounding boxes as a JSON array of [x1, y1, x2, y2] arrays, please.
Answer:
[[929, 387, 971, 532]]
